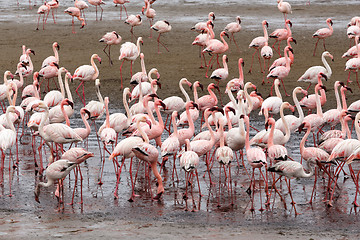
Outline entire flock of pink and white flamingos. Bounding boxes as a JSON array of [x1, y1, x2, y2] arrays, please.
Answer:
[[4, 0, 360, 215]]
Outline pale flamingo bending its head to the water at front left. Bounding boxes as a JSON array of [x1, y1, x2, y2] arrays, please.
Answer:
[[35, 159, 77, 203]]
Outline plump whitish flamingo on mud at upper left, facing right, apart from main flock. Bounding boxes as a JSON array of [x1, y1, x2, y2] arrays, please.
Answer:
[[119, 37, 143, 89]]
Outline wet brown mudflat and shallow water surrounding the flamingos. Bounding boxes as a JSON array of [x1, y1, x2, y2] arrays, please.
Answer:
[[0, 0, 359, 239]]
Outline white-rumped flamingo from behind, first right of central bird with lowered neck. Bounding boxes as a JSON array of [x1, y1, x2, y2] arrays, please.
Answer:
[[180, 139, 201, 211]]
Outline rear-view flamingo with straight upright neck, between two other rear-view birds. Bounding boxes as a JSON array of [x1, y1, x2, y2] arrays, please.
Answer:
[[215, 119, 234, 207]]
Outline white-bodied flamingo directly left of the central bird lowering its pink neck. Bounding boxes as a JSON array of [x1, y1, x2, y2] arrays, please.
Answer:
[[109, 114, 151, 202]]
